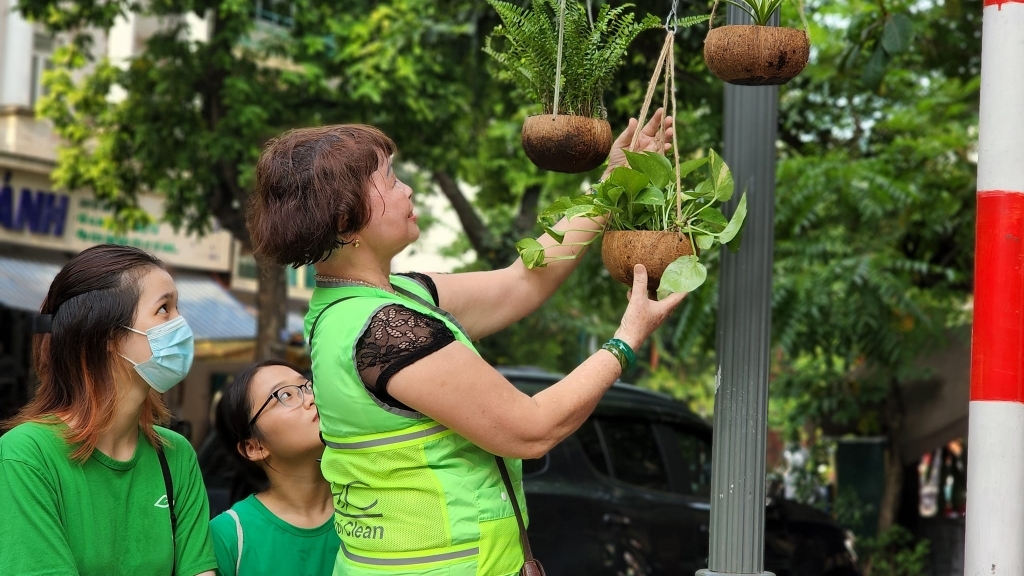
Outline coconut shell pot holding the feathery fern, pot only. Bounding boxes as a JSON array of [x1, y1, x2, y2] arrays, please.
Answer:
[[522, 114, 611, 173]]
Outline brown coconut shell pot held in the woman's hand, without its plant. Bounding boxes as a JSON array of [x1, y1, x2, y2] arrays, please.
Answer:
[[601, 230, 694, 293]]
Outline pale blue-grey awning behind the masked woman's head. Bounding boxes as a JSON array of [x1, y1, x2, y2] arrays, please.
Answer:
[[0, 252, 256, 340]]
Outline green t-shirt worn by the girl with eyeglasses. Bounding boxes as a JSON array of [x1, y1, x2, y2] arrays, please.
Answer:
[[210, 494, 341, 576]]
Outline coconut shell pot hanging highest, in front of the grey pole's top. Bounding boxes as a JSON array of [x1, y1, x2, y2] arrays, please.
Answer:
[[705, 25, 811, 86]]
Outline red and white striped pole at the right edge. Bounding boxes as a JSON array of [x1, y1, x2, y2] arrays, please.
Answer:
[[964, 0, 1024, 576]]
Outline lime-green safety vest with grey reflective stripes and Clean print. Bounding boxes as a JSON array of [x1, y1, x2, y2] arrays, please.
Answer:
[[305, 276, 526, 576]]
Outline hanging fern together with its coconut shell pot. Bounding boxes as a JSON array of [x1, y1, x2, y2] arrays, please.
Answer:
[[483, 0, 660, 173]]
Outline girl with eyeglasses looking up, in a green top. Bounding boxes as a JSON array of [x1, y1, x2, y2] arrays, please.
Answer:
[[210, 360, 340, 576]]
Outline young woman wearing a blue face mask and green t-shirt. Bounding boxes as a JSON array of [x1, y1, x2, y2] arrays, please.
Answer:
[[0, 245, 216, 576]]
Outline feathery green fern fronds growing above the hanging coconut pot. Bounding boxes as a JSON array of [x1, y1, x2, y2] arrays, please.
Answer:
[[483, 0, 663, 119]]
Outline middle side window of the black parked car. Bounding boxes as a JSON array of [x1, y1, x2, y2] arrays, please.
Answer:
[[598, 418, 669, 490]]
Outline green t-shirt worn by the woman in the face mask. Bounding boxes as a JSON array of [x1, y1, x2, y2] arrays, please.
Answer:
[[0, 416, 217, 576]]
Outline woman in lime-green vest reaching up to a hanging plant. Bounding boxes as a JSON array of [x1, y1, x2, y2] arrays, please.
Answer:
[[248, 111, 682, 576]]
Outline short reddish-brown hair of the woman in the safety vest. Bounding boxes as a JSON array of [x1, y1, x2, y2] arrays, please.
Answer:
[[246, 124, 395, 266]]
